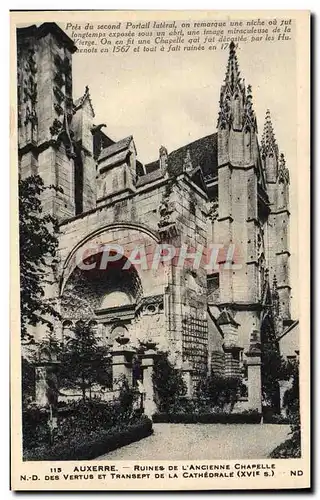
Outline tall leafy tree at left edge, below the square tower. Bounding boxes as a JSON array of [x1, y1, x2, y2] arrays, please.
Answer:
[[19, 175, 59, 340]]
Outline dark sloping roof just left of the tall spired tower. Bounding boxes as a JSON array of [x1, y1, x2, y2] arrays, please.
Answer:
[[146, 133, 218, 185]]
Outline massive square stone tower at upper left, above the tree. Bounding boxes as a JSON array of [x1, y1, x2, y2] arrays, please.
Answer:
[[17, 23, 76, 220]]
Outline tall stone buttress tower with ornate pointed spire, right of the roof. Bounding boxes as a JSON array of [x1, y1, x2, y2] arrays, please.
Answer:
[[217, 43, 268, 316]]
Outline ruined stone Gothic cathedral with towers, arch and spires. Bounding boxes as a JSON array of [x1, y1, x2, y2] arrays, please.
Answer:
[[17, 23, 299, 410]]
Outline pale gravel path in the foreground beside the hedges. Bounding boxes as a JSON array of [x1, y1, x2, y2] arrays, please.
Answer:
[[96, 424, 290, 460]]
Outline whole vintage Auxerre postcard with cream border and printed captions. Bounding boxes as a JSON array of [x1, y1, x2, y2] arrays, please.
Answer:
[[10, 11, 310, 491]]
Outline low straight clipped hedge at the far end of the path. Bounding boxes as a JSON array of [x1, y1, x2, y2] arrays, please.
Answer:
[[152, 412, 261, 424]]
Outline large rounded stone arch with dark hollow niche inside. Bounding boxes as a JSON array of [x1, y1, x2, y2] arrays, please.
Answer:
[[60, 225, 166, 350]]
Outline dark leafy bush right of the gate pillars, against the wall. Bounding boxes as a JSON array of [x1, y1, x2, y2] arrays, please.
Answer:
[[152, 353, 187, 412]]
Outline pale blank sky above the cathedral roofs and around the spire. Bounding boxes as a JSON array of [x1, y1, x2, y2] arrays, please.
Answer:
[[60, 23, 298, 314]]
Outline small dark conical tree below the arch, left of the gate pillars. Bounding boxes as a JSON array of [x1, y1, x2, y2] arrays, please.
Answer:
[[59, 321, 111, 401]]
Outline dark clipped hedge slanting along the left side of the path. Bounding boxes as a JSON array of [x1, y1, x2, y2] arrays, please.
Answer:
[[23, 417, 153, 461]]
